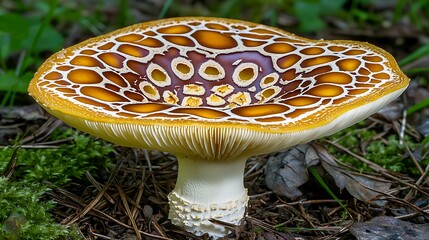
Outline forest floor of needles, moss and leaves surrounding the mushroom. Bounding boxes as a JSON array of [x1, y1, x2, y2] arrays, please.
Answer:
[[0, 1, 429, 240]]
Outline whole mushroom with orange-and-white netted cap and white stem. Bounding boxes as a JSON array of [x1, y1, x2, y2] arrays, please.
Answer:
[[28, 17, 409, 237]]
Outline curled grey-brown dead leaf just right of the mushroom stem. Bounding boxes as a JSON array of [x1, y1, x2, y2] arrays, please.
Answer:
[[265, 144, 391, 201]]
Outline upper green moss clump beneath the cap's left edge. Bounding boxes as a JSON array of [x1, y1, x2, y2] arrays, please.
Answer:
[[0, 130, 114, 186]]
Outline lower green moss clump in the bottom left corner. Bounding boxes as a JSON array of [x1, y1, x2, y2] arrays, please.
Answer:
[[0, 178, 77, 240]]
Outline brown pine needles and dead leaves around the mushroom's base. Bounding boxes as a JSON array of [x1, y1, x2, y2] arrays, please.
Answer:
[[0, 100, 429, 240]]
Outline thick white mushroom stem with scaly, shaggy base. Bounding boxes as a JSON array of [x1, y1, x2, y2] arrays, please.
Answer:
[[168, 156, 249, 237]]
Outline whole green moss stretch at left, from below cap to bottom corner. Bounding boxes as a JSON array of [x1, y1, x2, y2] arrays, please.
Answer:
[[0, 130, 114, 240]]
